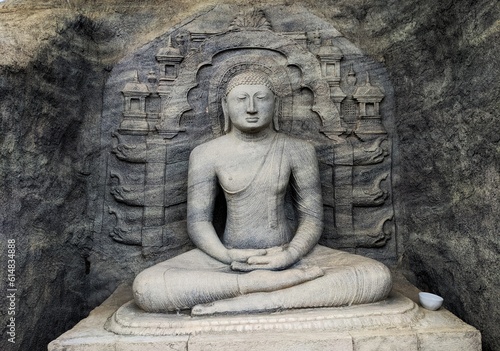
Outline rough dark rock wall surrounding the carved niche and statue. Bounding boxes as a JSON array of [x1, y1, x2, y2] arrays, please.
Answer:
[[0, 0, 500, 350]]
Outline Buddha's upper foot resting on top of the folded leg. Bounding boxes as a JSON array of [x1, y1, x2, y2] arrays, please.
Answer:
[[238, 266, 324, 295]]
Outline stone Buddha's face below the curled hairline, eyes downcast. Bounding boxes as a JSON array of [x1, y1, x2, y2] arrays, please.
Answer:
[[222, 85, 275, 133]]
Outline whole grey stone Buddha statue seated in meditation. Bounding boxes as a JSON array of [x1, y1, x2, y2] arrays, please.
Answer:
[[133, 71, 392, 315]]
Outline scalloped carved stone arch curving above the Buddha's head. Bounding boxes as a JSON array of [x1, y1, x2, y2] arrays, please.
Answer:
[[156, 29, 345, 139]]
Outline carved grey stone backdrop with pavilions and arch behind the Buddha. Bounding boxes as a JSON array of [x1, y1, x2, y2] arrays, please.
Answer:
[[103, 8, 396, 259]]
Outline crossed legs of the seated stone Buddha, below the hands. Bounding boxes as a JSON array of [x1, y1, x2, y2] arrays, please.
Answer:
[[133, 246, 391, 315]]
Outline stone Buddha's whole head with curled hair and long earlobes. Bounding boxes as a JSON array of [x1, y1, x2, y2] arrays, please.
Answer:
[[222, 71, 276, 133]]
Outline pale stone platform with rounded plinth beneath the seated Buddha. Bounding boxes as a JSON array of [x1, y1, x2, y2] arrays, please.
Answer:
[[49, 278, 481, 351]]
